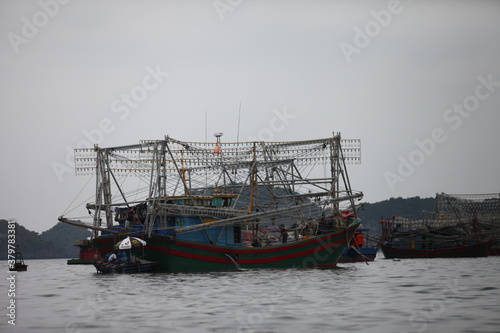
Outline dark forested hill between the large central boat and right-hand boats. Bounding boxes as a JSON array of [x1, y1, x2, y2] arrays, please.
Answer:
[[359, 197, 435, 233]]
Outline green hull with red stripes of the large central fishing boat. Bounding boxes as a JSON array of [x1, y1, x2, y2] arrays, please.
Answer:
[[95, 221, 359, 272]]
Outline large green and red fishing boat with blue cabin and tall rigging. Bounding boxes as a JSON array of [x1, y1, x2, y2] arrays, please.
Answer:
[[59, 133, 363, 272]]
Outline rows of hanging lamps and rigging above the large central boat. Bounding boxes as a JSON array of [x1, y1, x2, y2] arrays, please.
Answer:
[[75, 137, 361, 205]]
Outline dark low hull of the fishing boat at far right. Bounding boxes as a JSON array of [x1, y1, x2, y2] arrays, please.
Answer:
[[381, 242, 491, 259]]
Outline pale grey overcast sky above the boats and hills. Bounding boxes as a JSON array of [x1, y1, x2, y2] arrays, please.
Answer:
[[0, 0, 500, 232]]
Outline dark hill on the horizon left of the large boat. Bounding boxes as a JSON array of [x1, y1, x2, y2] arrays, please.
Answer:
[[0, 220, 90, 260]]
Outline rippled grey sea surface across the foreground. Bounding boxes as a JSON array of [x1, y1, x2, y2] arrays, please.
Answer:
[[0, 257, 500, 333]]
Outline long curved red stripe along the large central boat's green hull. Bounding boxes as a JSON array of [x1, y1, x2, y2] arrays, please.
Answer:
[[147, 236, 345, 265]]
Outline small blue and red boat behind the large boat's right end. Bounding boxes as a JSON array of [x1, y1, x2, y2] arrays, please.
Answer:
[[338, 228, 378, 263]]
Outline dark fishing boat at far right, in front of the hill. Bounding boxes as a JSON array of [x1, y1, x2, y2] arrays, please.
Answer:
[[379, 216, 493, 259]]
